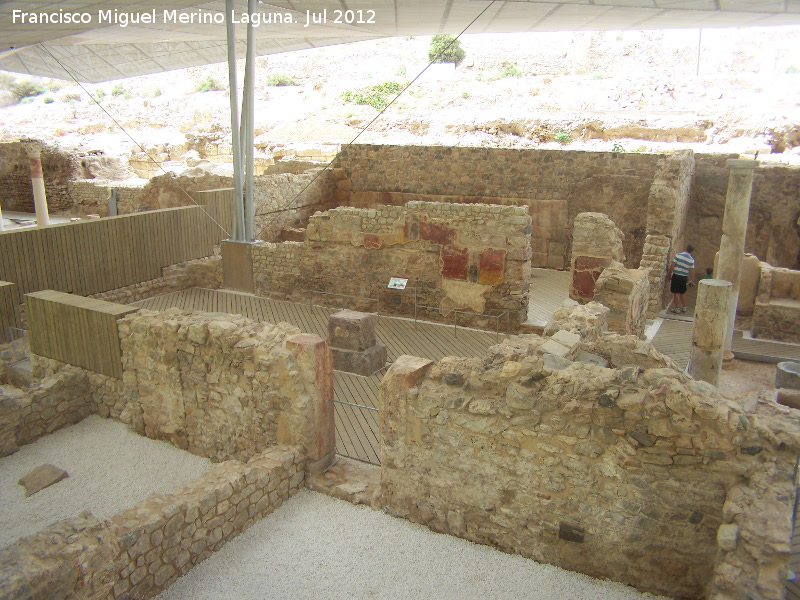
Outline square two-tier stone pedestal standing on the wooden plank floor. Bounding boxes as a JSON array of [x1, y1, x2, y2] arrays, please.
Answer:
[[328, 310, 387, 375]]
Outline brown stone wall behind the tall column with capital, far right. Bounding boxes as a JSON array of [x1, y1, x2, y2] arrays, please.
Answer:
[[685, 154, 800, 272]]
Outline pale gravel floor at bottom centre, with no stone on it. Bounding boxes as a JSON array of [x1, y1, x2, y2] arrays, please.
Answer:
[[157, 490, 668, 600]]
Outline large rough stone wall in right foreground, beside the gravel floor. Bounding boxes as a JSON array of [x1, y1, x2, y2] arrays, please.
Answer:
[[380, 303, 800, 600]]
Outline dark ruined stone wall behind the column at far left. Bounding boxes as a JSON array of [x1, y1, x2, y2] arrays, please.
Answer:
[[0, 143, 77, 213]]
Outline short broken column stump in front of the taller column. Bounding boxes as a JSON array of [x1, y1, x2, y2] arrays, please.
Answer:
[[689, 279, 731, 386]]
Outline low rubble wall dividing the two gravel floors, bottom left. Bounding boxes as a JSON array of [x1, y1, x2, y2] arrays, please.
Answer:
[[0, 446, 306, 600]]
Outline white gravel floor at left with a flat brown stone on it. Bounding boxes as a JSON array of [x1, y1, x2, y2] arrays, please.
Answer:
[[0, 416, 213, 547]]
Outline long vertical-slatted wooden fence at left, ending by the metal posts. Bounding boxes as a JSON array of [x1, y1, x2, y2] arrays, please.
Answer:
[[0, 190, 233, 296]]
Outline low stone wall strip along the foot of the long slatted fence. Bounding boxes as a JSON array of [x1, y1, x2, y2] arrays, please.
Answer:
[[89, 256, 222, 304]]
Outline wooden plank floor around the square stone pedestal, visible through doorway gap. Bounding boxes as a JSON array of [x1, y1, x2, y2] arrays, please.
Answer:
[[135, 288, 505, 464]]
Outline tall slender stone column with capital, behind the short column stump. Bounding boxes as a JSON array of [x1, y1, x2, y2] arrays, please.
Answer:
[[714, 158, 758, 360]]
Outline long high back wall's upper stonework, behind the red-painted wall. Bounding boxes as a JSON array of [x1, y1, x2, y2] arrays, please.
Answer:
[[334, 144, 660, 268]]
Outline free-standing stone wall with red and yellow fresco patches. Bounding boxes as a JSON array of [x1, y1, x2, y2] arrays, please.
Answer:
[[253, 202, 531, 329]]
